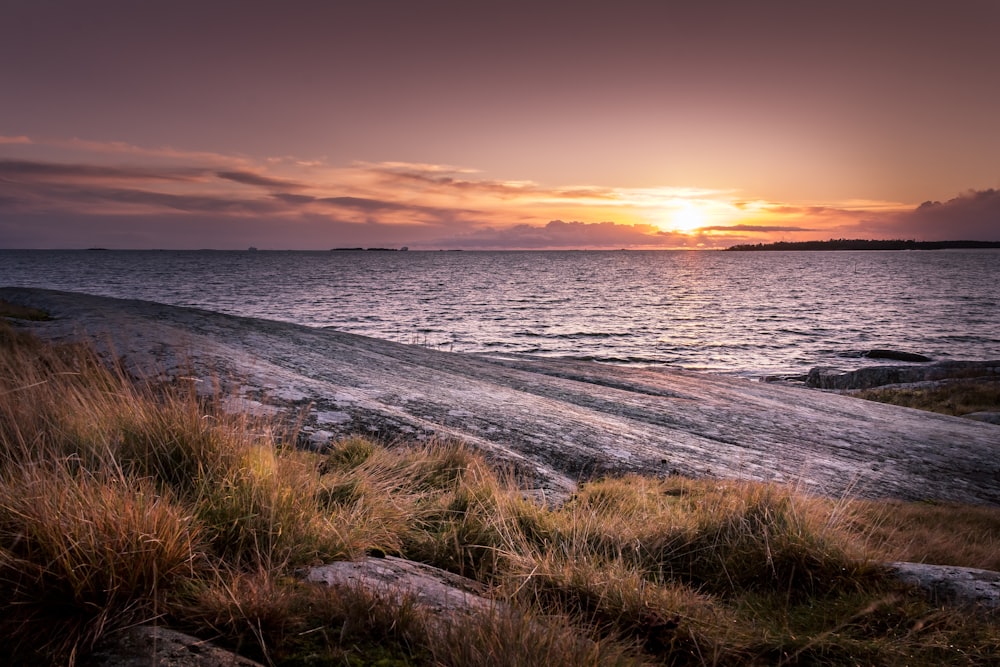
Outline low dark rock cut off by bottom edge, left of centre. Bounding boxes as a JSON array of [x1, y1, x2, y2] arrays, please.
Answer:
[[81, 625, 262, 667]]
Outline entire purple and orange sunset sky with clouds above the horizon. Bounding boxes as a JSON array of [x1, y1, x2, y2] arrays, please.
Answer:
[[0, 0, 1000, 250]]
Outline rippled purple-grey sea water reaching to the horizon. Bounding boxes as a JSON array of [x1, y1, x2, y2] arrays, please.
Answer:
[[0, 250, 1000, 377]]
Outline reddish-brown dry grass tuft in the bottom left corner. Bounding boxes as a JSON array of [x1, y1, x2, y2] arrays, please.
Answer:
[[0, 460, 203, 657]]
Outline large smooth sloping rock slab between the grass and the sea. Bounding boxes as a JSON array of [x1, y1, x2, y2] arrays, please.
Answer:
[[0, 288, 1000, 504]]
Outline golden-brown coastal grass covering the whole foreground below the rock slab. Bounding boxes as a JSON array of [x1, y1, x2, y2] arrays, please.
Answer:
[[0, 320, 1000, 666]]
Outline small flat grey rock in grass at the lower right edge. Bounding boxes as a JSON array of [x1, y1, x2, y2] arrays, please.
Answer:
[[889, 563, 1000, 611]]
